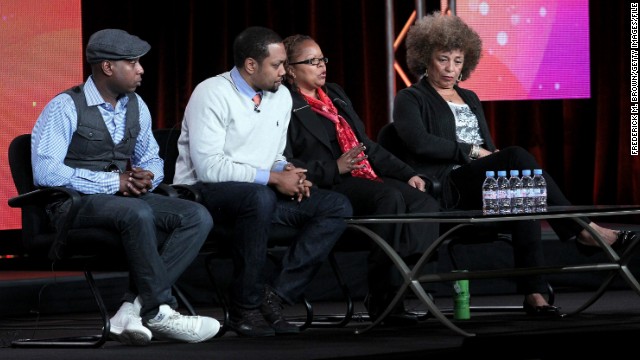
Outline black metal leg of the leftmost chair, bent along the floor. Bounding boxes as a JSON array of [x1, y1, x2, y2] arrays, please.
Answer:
[[11, 270, 111, 348]]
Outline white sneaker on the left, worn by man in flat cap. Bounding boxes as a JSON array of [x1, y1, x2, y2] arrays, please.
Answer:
[[109, 298, 152, 346]]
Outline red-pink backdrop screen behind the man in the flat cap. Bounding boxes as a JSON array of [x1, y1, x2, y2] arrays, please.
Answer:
[[0, 0, 83, 230]]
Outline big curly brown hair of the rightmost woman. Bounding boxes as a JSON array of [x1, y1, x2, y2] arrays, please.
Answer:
[[406, 12, 482, 80]]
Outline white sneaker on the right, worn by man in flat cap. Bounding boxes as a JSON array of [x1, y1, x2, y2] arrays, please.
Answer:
[[147, 305, 220, 343]]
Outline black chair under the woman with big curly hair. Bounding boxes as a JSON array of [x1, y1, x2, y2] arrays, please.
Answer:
[[378, 122, 555, 311]]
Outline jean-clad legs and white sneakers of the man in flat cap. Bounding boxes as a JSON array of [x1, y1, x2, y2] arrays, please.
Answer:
[[76, 194, 220, 345]]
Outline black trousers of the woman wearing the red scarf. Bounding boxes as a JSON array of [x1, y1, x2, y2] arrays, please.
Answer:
[[331, 177, 439, 293]]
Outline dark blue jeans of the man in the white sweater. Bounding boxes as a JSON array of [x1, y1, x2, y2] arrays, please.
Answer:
[[195, 182, 352, 309]]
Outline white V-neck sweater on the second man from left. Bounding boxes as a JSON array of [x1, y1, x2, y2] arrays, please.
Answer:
[[173, 72, 291, 184]]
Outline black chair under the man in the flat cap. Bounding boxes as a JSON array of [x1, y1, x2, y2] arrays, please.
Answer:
[[8, 134, 193, 348]]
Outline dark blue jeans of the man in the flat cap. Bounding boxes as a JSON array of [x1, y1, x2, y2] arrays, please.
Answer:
[[53, 193, 213, 321]]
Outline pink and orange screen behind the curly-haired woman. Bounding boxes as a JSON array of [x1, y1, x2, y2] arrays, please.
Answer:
[[456, 0, 591, 101]]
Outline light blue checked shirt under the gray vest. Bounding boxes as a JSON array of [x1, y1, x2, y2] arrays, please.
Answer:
[[31, 76, 164, 194]]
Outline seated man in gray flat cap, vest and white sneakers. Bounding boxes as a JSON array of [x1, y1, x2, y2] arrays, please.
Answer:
[[31, 29, 220, 345]]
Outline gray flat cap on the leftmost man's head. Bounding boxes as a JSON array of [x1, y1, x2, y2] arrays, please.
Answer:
[[86, 29, 151, 64]]
